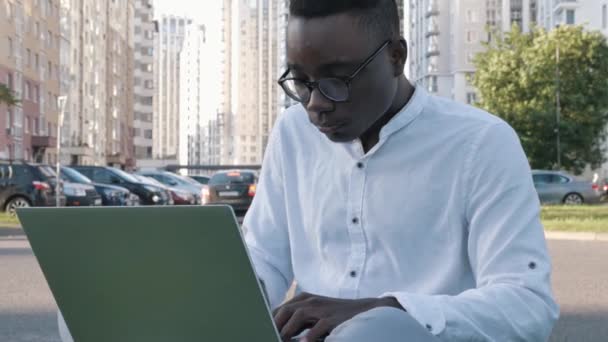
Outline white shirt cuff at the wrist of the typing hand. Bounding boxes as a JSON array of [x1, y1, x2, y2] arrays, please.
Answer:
[[380, 292, 446, 336]]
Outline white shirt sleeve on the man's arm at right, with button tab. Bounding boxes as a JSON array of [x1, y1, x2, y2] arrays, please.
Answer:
[[383, 122, 559, 341]]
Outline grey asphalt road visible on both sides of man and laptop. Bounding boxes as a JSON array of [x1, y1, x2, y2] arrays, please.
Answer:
[[0, 229, 608, 342]]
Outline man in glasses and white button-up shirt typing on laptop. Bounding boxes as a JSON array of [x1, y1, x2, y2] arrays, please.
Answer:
[[244, 0, 558, 342]]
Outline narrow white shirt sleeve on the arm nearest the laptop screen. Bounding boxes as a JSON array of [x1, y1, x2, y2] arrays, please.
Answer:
[[243, 123, 293, 308]]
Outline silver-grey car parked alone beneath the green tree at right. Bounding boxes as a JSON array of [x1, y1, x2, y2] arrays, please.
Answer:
[[532, 170, 600, 205]]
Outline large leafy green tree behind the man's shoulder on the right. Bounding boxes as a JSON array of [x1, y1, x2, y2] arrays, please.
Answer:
[[473, 26, 608, 173]]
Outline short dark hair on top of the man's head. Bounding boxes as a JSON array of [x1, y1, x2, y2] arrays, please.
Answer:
[[289, 0, 401, 39]]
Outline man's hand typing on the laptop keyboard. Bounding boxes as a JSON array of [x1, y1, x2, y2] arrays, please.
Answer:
[[273, 293, 403, 342]]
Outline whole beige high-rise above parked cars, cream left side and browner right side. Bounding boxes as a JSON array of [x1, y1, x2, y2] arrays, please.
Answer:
[[61, 0, 135, 168]]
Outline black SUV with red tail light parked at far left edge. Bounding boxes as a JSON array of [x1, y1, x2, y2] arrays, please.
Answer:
[[0, 160, 66, 215]]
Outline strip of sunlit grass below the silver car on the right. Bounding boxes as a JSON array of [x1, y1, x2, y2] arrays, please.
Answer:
[[541, 206, 608, 233]]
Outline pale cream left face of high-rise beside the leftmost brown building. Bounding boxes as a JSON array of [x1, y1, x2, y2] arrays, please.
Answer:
[[61, 0, 107, 165]]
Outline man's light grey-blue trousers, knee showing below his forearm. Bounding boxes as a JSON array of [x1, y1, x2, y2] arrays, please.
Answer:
[[57, 308, 437, 342]]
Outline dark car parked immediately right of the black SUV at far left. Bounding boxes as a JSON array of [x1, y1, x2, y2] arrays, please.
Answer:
[[61, 166, 139, 207]]
